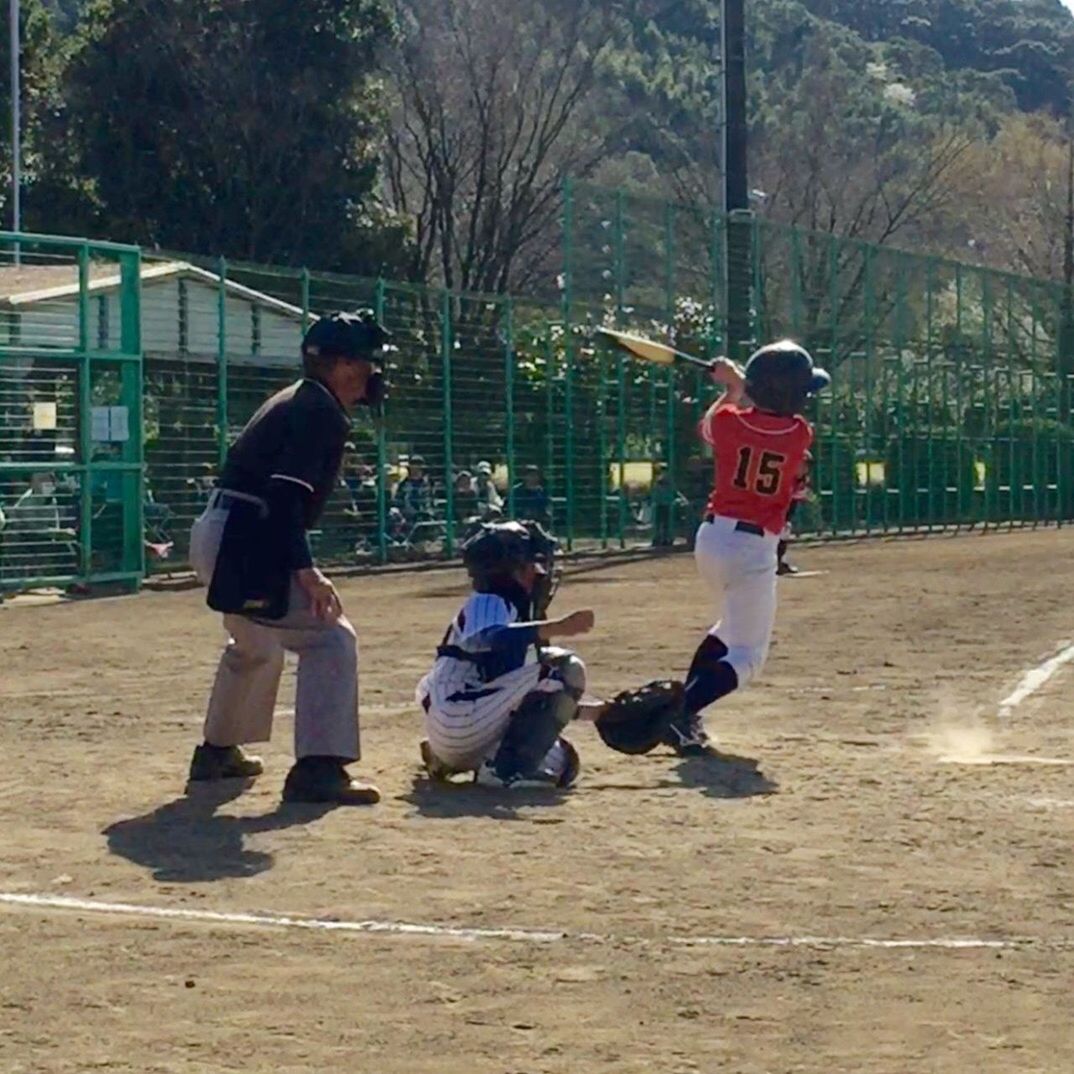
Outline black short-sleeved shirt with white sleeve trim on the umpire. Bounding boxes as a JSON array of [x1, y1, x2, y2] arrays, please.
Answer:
[[219, 379, 350, 529]]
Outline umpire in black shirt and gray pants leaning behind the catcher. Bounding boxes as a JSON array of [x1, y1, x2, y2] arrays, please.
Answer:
[[190, 310, 388, 806]]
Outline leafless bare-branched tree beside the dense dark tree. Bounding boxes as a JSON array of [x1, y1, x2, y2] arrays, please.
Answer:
[[387, 0, 615, 293]]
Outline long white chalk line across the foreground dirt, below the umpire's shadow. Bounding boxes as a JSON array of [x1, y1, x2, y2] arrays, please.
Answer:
[[0, 892, 1074, 950]]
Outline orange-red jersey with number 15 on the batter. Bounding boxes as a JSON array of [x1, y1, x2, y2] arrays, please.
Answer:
[[700, 403, 813, 534]]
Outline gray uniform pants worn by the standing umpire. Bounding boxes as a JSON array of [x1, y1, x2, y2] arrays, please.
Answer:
[[190, 499, 361, 761]]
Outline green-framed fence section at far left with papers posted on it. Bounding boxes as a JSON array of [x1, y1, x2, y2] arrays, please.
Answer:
[[0, 233, 144, 595]]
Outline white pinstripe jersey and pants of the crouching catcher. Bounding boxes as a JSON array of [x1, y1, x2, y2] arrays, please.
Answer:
[[417, 593, 565, 772]]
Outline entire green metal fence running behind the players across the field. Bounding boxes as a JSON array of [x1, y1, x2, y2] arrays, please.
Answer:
[[0, 180, 1074, 590]]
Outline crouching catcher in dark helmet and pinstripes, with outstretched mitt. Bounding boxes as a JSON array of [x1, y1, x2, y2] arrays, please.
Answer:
[[417, 522, 682, 789]]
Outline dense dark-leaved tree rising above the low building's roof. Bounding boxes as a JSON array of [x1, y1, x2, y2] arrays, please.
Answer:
[[46, 0, 402, 273]]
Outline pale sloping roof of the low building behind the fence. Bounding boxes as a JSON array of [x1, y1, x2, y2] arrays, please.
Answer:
[[0, 261, 302, 320]]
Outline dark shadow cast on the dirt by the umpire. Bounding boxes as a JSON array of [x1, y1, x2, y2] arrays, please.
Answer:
[[103, 780, 332, 884]]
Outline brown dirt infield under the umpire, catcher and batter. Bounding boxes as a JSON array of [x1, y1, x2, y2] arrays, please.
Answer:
[[0, 531, 1074, 1074]]
